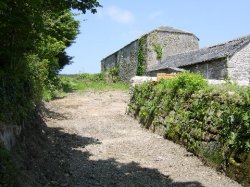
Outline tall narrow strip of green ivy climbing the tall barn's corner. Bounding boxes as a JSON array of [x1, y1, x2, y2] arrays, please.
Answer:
[[136, 36, 146, 76]]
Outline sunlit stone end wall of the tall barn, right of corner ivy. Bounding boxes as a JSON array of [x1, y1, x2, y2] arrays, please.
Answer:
[[146, 31, 199, 69]]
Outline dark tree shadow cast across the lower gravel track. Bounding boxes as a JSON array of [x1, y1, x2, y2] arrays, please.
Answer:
[[14, 109, 203, 187]]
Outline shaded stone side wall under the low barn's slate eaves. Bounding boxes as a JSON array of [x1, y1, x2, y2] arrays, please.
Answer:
[[181, 59, 228, 80]]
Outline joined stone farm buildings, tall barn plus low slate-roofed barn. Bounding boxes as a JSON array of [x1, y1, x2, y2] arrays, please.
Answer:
[[102, 27, 250, 83]]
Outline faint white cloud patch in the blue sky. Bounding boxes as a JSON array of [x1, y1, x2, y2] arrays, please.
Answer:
[[107, 6, 134, 24]]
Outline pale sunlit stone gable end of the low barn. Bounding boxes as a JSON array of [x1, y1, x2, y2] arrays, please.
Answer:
[[227, 44, 250, 82]]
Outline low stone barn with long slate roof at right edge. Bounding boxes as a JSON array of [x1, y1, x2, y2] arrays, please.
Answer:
[[147, 35, 250, 83]]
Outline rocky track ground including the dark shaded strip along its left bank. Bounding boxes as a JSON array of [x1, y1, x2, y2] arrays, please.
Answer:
[[14, 91, 240, 187]]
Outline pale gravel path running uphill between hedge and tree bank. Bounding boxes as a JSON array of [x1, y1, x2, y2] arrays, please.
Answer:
[[47, 91, 240, 187]]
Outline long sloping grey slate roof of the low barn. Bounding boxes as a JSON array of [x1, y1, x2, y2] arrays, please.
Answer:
[[148, 35, 250, 71]]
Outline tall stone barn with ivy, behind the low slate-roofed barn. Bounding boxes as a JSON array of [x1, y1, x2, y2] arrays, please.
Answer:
[[101, 27, 199, 81]]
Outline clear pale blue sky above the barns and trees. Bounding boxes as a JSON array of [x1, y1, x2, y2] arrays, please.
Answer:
[[61, 0, 250, 74]]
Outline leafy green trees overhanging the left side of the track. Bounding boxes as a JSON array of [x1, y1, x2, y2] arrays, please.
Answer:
[[0, 0, 100, 125]]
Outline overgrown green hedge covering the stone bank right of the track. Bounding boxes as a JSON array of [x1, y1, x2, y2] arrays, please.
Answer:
[[129, 73, 250, 186]]
